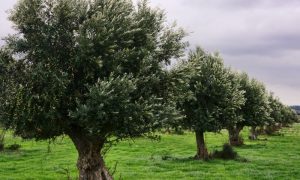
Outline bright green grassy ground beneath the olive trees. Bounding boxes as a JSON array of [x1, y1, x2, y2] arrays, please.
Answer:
[[0, 124, 300, 180]]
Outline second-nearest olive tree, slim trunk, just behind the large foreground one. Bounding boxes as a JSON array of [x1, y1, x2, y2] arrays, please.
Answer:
[[173, 48, 244, 159]]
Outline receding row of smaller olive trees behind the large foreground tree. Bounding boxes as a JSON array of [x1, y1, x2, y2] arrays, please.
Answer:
[[170, 48, 298, 159]]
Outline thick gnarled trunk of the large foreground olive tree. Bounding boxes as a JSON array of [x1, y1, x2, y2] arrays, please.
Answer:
[[70, 135, 113, 180]]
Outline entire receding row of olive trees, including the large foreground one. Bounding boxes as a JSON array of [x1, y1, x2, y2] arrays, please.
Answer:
[[0, 0, 298, 180]]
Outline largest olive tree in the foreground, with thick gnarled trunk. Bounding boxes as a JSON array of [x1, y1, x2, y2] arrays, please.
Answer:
[[1, 0, 186, 179]]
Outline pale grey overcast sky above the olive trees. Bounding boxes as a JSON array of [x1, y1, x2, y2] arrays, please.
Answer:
[[0, 0, 300, 105]]
